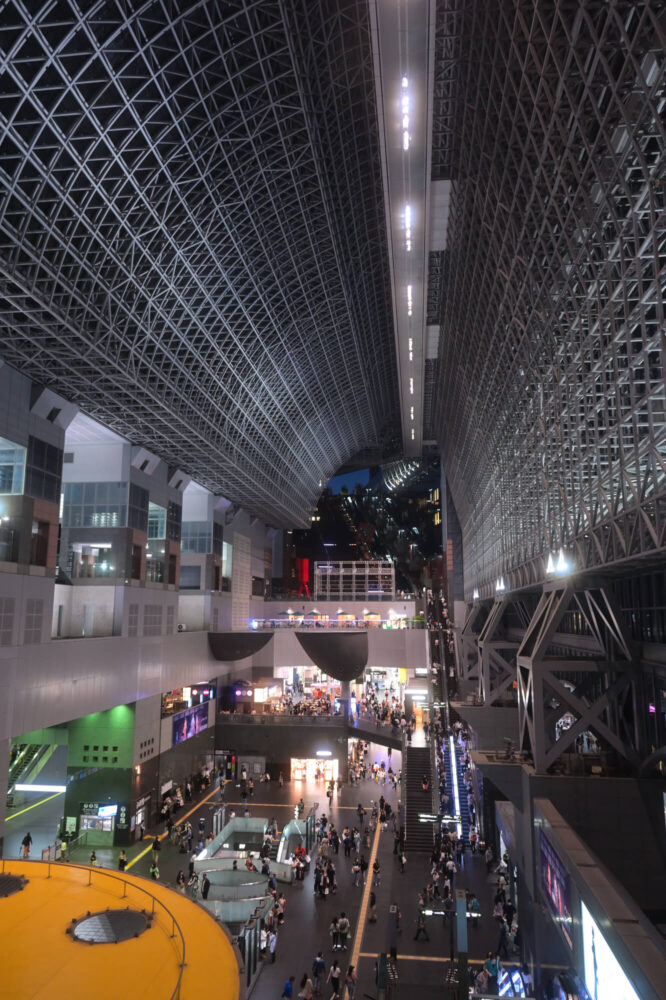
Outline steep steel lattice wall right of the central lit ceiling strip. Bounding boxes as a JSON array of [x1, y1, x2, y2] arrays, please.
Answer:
[[433, 0, 666, 597]]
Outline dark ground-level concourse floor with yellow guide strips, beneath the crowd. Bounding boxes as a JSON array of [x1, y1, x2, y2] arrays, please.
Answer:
[[11, 744, 524, 1000]]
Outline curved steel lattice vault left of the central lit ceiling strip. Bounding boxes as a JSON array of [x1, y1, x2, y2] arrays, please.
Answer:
[[0, 0, 400, 524]]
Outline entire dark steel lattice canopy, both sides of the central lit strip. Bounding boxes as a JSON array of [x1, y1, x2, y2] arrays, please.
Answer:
[[0, 0, 666, 597]]
